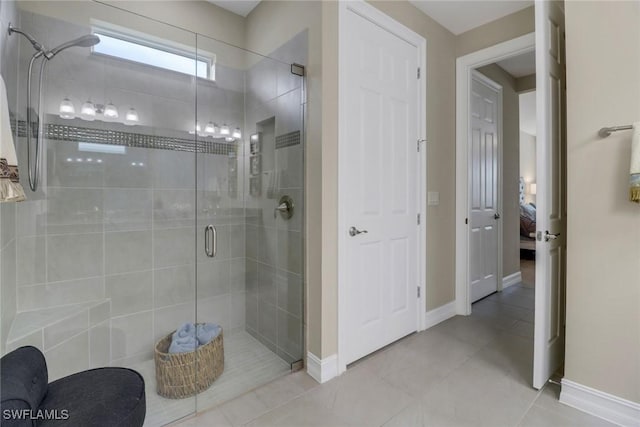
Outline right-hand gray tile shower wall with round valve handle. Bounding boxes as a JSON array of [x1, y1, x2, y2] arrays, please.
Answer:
[[245, 32, 307, 362]]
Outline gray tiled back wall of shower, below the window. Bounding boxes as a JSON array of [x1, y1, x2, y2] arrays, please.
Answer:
[[6, 13, 245, 379]]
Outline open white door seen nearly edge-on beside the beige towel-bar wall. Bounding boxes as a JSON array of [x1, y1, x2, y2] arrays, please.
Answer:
[[533, 0, 566, 389]]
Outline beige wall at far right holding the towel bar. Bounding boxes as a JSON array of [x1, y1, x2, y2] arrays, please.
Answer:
[[565, 1, 640, 403]]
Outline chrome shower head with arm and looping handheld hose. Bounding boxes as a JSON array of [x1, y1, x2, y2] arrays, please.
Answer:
[[7, 23, 100, 191]]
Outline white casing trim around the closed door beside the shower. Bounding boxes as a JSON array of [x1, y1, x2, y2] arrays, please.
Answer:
[[337, 0, 427, 375]]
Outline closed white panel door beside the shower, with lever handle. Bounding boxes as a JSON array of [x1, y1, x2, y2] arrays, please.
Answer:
[[340, 5, 420, 364]]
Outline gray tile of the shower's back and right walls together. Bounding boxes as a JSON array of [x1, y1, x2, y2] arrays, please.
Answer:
[[0, 8, 307, 379]]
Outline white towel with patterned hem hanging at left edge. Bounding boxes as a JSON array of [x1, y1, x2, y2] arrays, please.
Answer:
[[0, 76, 25, 202]]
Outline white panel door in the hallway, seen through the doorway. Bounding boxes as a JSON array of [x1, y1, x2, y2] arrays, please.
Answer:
[[469, 71, 501, 303]]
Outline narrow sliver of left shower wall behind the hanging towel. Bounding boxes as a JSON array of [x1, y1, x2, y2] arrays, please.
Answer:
[[0, 1, 19, 355]]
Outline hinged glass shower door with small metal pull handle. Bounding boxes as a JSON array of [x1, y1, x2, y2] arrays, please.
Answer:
[[196, 35, 303, 411]]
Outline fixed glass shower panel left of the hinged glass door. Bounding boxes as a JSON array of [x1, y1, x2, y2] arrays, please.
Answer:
[[7, 3, 196, 425]]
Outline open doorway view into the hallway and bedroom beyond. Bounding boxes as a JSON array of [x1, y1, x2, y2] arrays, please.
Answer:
[[469, 50, 536, 348]]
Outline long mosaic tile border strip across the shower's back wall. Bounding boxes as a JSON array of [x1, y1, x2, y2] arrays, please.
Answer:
[[12, 120, 238, 156]]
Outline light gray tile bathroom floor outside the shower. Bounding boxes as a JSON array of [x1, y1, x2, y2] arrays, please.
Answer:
[[172, 284, 611, 427]]
